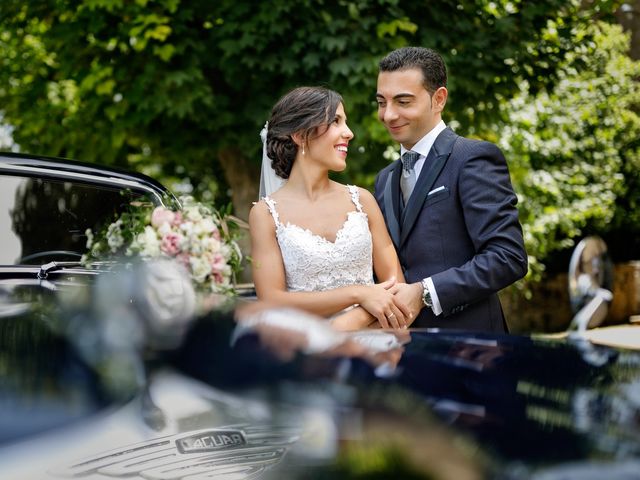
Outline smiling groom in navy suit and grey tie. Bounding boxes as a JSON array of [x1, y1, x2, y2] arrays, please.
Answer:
[[375, 47, 527, 332]]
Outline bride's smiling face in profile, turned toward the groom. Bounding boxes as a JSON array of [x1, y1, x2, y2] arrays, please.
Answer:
[[307, 104, 353, 172]]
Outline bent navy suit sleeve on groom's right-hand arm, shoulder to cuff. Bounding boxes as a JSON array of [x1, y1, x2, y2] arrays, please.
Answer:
[[431, 142, 528, 315]]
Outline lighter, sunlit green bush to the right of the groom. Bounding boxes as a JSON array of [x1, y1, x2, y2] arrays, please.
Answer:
[[496, 22, 640, 278]]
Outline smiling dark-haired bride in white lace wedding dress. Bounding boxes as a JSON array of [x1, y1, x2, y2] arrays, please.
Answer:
[[249, 87, 413, 330]]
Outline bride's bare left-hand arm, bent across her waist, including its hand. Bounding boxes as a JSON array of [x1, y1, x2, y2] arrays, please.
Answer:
[[249, 202, 402, 324]]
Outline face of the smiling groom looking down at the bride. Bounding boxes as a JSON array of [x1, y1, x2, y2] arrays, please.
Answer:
[[376, 68, 442, 149]]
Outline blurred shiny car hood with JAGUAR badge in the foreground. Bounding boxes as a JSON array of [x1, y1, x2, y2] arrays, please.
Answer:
[[0, 298, 640, 479]]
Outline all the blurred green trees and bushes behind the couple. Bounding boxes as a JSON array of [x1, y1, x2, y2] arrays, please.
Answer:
[[0, 0, 640, 308]]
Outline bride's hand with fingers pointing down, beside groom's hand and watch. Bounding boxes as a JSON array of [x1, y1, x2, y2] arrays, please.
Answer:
[[359, 277, 409, 328]]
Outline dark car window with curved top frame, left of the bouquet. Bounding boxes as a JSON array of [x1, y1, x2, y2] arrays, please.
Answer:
[[0, 169, 163, 266]]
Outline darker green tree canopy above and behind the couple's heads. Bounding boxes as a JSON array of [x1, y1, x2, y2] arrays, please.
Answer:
[[0, 0, 611, 199]]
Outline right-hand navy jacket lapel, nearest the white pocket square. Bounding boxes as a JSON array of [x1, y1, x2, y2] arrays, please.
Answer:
[[397, 128, 458, 246]]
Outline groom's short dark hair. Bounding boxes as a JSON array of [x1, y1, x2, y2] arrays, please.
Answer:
[[378, 47, 447, 93]]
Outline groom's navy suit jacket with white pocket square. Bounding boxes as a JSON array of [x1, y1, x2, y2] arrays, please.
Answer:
[[375, 128, 528, 332]]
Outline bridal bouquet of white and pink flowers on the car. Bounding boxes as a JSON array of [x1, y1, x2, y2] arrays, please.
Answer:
[[82, 197, 242, 294]]
